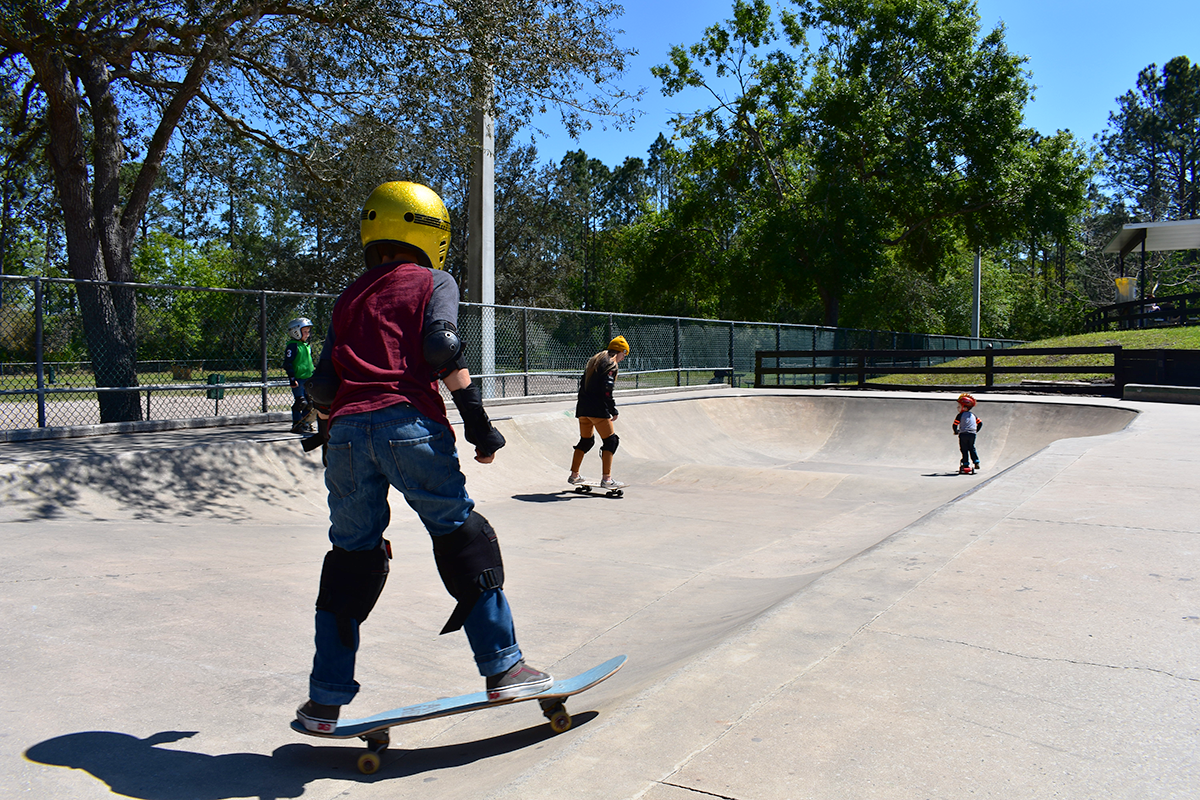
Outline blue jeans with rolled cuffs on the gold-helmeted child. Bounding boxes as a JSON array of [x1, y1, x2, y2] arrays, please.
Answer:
[[308, 404, 521, 705]]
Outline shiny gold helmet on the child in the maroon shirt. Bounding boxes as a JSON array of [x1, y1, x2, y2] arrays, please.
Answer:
[[359, 181, 450, 270]]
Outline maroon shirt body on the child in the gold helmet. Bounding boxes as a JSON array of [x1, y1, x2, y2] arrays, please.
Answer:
[[322, 264, 458, 427]]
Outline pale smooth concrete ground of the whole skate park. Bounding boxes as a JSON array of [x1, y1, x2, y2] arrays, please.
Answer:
[[0, 389, 1200, 800]]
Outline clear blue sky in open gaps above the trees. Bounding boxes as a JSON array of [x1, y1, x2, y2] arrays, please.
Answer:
[[538, 0, 1200, 167]]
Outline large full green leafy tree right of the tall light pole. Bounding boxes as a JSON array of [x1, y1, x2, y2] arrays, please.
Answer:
[[643, 0, 1088, 325]]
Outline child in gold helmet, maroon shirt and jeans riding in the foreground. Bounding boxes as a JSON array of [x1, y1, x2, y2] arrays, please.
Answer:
[[296, 181, 553, 733]]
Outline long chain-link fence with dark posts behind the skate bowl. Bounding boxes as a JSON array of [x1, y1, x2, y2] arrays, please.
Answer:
[[0, 276, 1012, 431]]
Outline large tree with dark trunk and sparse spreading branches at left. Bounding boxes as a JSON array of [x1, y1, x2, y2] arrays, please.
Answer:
[[0, 0, 626, 421]]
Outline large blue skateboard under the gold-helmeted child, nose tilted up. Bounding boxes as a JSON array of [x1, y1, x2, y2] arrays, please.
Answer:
[[292, 656, 625, 775]]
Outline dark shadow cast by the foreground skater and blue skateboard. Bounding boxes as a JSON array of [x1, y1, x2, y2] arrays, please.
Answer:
[[25, 711, 599, 800]]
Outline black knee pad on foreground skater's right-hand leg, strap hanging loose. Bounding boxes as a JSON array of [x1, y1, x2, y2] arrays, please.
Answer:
[[433, 511, 504, 633]]
